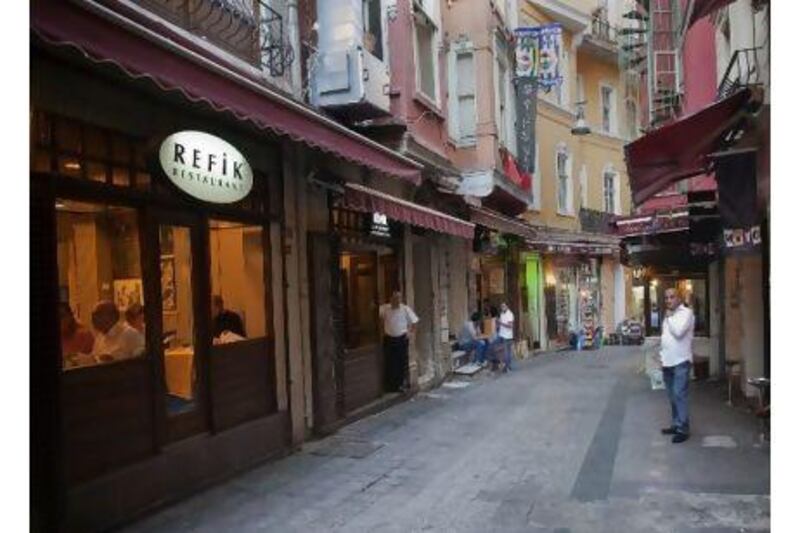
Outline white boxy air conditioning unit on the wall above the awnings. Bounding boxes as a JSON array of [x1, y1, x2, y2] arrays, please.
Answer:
[[311, 46, 390, 120]]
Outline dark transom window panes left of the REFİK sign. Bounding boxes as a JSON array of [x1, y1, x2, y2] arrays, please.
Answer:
[[31, 110, 150, 189]]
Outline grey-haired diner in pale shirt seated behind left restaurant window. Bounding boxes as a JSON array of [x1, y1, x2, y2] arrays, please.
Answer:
[[92, 300, 145, 363]]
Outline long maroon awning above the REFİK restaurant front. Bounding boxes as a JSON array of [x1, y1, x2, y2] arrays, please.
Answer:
[[31, 0, 422, 184]]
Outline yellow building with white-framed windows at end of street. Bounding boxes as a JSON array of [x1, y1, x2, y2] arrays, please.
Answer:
[[519, 0, 638, 345]]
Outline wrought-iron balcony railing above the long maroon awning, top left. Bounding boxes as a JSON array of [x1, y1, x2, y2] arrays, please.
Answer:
[[136, 0, 294, 77]]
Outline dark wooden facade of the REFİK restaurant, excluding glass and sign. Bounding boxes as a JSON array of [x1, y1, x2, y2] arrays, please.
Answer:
[[31, 43, 291, 531]]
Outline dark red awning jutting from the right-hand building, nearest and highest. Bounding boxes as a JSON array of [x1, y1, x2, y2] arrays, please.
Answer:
[[625, 89, 751, 204]]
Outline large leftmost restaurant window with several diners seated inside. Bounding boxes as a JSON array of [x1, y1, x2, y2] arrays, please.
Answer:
[[55, 200, 145, 369]]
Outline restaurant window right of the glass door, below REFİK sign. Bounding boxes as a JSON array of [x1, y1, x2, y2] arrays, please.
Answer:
[[209, 219, 267, 345]]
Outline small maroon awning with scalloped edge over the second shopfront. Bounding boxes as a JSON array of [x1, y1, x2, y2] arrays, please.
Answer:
[[342, 183, 475, 239]]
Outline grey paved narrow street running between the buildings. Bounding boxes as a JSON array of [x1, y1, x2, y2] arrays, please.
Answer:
[[126, 347, 770, 532]]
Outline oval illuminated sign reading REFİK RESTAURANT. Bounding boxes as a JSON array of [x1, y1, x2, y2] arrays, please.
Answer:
[[158, 131, 253, 204]]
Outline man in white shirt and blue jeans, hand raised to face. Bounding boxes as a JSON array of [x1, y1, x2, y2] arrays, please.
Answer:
[[661, 289, 694, 444]]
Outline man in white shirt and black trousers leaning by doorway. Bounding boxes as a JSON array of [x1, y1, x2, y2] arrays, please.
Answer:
[[380, 290, 419, 391]]
